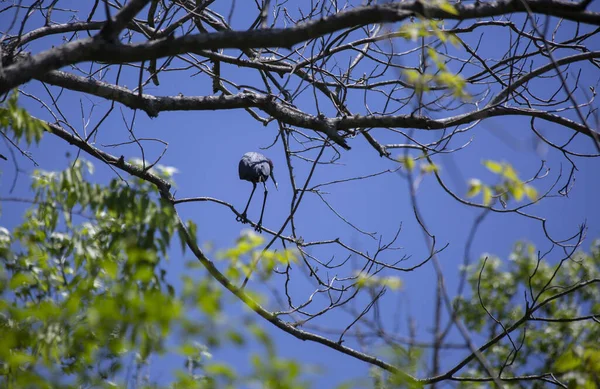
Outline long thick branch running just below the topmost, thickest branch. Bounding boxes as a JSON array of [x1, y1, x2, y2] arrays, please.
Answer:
[[39, 69, 600, 142]]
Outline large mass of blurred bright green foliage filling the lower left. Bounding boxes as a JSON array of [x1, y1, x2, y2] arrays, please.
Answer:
[[0, 160, 302, 389]]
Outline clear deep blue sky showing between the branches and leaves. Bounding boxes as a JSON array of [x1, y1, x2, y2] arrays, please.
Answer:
[[0, 2, 600, 387]]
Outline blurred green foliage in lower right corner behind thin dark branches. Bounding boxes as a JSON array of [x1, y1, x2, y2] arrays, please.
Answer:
[[455, 241, 600, 388]]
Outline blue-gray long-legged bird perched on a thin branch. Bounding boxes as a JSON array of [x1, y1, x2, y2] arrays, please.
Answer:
[[236, 151, 277, 232]]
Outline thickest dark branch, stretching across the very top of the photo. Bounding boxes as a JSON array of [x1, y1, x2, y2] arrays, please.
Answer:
[[0, 0, 600, 94]]
